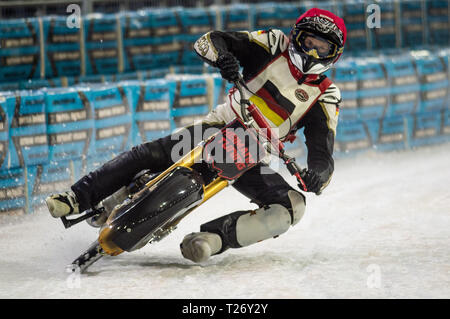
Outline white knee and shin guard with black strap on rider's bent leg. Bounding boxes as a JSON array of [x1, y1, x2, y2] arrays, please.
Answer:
[[200, 190, 305, 253]]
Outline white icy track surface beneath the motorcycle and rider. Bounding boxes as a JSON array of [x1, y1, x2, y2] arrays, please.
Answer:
[[0, 144, 450, 298]]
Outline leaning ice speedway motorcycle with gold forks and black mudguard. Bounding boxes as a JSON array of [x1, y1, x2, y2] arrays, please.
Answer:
[[61, 80, 306, 273]]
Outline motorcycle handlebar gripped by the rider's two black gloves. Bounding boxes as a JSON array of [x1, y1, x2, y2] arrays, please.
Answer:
[[234, 78, 308, 191]]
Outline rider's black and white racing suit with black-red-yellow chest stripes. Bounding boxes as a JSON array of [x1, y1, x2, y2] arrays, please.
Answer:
[[72, 30, 341, 252]]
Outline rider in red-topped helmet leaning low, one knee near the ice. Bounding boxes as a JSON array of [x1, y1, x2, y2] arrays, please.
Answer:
[[46, 8, 346, 262]]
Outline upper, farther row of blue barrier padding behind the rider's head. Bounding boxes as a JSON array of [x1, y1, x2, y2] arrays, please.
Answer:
[[0, 0, 450, 90]]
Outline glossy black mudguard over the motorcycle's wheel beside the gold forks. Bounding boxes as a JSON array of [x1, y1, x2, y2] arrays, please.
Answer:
[[99, 166, 204, 254]]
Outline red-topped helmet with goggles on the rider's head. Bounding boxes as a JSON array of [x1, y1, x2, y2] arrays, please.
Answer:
[[289, 8, 347, 74]]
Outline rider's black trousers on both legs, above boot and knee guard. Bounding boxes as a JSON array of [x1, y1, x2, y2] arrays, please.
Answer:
[[72, 123, 292, 211]]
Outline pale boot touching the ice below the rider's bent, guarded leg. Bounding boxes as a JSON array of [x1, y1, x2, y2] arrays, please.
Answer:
[[180, 232, 222, 263]]
